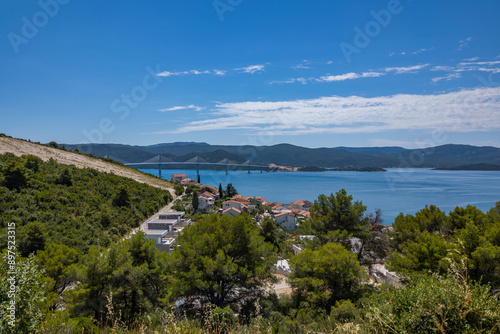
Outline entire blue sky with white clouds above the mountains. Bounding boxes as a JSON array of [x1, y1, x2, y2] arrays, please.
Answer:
[[0, 0, 500, 148]]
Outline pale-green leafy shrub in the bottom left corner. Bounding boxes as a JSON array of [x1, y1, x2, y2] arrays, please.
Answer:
[[0, 251, 47, 334]]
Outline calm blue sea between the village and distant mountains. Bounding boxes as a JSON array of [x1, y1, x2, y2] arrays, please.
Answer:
[[141, 168, 500, 224]]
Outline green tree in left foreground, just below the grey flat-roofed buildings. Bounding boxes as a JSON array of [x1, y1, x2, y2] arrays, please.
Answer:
[[71, 232, 167, 322]]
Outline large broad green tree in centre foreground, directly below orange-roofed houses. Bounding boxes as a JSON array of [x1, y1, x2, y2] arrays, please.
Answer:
[[170, 215, 276, 307]]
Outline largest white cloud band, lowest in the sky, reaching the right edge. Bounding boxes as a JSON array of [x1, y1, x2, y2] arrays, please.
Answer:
[[163, 87, 500, 135]]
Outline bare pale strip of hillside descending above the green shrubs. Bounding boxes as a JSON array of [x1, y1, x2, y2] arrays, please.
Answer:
[[0, 137, 172, 189]]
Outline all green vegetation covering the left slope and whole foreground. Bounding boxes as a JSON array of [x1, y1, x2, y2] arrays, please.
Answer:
[[0, 155, 500, 333]]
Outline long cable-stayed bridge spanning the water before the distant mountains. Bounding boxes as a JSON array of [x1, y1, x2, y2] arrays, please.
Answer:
[[104, 154, 269, 178]]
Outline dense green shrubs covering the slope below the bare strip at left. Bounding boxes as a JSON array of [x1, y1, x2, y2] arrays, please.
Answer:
[[0, 154, 171, 252]]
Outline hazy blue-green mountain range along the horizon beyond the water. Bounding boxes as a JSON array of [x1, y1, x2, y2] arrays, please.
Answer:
[[65, 142, 500, 168]]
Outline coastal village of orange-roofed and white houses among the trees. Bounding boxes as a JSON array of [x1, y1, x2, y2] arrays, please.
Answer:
[[140, 174, 399, 284]]
